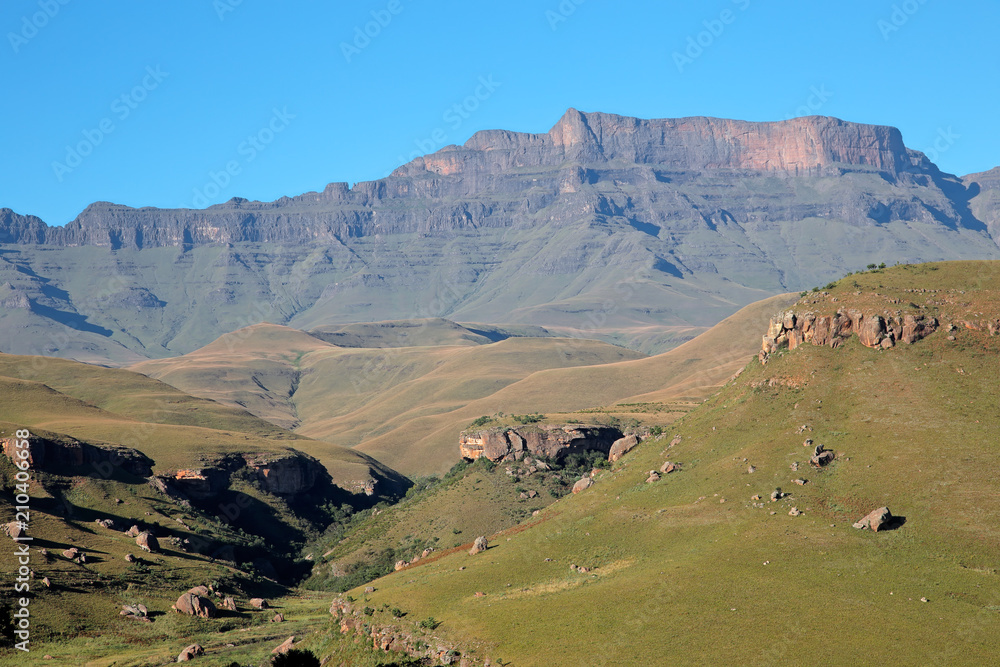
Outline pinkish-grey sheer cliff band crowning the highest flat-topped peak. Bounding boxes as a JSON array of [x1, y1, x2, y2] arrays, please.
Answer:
[[402, 109, 916, 178]]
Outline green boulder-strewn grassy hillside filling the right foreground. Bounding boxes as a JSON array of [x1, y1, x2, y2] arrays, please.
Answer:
[[332, 262, 1000, 665]]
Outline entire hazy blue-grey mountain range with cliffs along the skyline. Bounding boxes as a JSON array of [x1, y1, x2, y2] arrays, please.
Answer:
[[0, 109, 1000, 364]]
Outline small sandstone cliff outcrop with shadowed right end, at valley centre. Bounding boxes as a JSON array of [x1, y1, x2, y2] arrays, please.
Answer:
[[459, 424, 622, 462]]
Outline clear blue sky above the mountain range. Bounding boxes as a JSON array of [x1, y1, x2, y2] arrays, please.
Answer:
[[0, 0, 1000, 224]]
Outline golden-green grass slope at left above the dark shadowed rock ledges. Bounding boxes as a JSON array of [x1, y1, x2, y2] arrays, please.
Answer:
[[0, 355, 394, 486]]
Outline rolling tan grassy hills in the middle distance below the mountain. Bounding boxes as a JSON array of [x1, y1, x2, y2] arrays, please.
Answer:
[[132, 295, 795, 475]]
